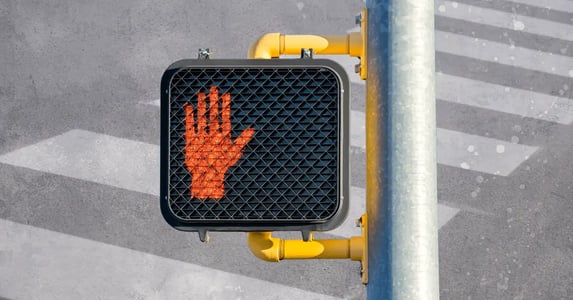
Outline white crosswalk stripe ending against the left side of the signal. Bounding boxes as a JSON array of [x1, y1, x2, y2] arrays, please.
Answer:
[[0, 130, 159, 196]]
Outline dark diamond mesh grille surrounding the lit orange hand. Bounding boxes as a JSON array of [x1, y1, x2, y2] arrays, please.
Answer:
[[168, 66, 341, 224]]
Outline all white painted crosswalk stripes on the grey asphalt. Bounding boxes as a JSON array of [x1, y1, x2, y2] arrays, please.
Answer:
[[0, 0, 573, 299]]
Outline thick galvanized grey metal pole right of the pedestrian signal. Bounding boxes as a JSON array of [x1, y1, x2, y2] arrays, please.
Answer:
[[366, 0, 439, 300]]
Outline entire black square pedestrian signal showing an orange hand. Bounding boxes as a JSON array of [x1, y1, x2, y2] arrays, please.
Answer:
[[160, 59, 349, 232]]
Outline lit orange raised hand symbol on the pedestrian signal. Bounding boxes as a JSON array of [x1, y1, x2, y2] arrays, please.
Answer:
[[184, 86, 255, 199]]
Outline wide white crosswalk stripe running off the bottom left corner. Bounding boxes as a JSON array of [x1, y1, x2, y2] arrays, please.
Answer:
[[0, 219, 338, 300]]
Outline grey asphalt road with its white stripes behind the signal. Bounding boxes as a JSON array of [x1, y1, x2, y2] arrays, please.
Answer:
[[0, 0, 573, 299]]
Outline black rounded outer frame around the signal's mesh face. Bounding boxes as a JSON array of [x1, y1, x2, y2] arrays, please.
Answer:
[[160, 59, 350, 232]]
